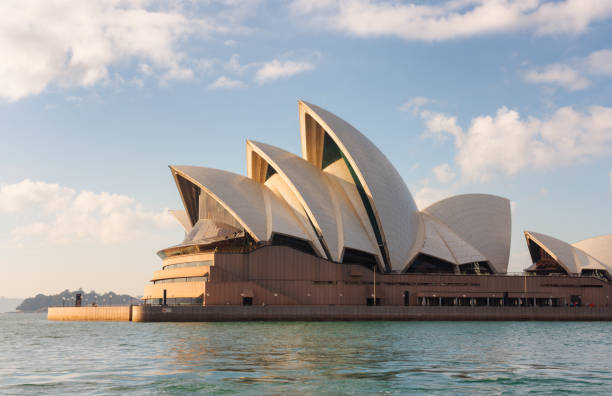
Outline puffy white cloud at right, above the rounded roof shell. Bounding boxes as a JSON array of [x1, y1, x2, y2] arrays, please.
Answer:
[[421, 106, 612, 181]]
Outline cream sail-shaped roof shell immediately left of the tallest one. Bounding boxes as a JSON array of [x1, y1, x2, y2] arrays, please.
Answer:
[[247, 141, 379, 262]]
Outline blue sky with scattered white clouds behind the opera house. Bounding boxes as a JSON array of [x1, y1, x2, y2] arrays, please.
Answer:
[[0, 0, 612, 297]]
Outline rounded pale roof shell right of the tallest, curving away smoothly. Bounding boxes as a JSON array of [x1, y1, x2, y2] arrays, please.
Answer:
[[423, 194, 512, 273]]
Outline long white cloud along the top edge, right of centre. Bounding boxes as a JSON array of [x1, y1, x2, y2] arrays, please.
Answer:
[[292, 0, 612, 41]]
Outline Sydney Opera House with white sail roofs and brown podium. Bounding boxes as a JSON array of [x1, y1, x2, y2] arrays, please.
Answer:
[[143, 101, 612, 306]]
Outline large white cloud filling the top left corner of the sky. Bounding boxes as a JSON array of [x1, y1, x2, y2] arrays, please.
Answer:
[[0, 0, 252, 102]]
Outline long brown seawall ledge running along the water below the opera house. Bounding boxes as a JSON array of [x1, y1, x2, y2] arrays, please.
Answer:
[[132, 305, 612, 322]]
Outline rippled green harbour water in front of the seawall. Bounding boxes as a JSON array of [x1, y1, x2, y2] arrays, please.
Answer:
[[0, 314, 612, 395]]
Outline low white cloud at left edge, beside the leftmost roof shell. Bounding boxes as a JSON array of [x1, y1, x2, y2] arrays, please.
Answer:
[[0, 179, 174, 244]]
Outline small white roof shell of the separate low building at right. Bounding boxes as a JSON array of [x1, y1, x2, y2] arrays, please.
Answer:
[[525, 231, 607, 274]]
